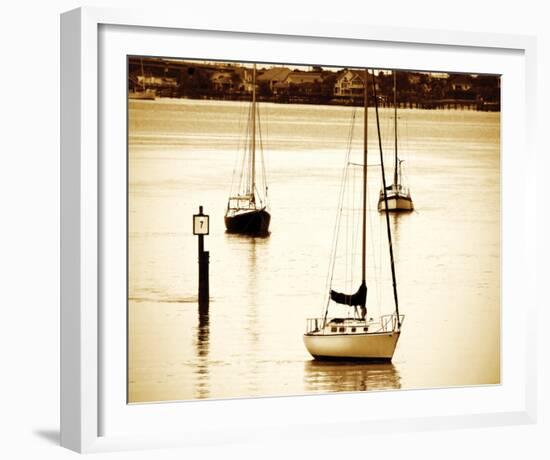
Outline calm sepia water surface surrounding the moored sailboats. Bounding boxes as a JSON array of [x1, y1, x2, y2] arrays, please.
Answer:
[[129, 100, 500, 402]]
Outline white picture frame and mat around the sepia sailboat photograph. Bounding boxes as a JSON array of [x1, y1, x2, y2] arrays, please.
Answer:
[[61, 7, 537, 452]]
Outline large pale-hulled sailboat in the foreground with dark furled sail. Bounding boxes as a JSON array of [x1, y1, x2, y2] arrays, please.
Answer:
[[303, 69, 404, 361]]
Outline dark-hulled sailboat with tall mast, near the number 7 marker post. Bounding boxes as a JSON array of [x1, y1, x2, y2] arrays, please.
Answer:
[[224, 64, 271, 236]]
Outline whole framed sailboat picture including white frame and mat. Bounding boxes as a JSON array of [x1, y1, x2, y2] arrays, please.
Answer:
[[61, 8, 537, 452]]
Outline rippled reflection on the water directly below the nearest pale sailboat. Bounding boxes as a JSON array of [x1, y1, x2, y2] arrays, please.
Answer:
[[304, 360, 401, 392]]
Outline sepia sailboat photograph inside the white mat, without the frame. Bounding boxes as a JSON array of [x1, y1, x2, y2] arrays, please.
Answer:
[[127, 56, 501, 403]]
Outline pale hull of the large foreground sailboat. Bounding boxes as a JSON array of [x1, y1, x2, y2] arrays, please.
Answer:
[[304, 331, 400, 361]]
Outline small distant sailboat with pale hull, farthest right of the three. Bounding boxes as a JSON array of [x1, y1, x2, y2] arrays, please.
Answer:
[[378, 70, 414, 212]]
